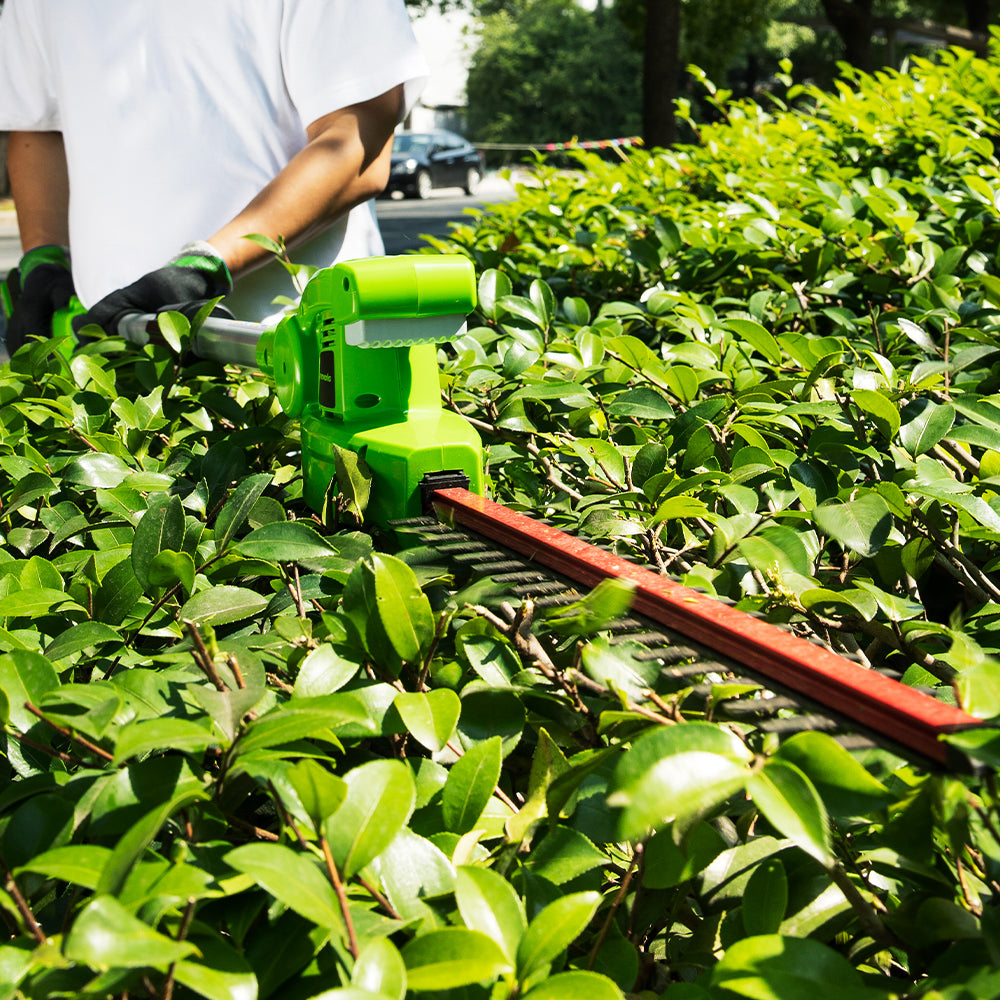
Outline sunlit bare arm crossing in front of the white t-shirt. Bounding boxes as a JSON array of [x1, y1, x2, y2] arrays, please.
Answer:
[[208, 88, 402, 278]]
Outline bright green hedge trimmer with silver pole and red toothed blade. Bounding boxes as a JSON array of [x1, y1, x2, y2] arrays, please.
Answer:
[[0, 255, 980, 767]]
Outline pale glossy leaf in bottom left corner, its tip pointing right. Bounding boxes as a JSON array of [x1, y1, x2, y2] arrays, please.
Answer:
[[63, 896, 197, 972]]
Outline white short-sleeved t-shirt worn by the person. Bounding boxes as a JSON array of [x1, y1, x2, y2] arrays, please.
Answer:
[[0, 0, 427, 319]]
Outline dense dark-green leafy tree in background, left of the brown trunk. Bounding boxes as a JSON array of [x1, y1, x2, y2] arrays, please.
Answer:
[[467, 0, 640, 144]]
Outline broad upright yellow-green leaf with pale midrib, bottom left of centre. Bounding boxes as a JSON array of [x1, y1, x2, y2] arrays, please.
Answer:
[[323, 760, 417, 878]]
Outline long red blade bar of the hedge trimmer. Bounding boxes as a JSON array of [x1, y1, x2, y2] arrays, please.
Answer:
[[433, 489, 982, 764]]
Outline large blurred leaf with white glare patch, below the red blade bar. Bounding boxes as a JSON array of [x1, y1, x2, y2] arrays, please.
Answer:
[[608, 722, 751, 839]]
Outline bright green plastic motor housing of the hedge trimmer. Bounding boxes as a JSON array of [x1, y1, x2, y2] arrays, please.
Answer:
[[257, 255, 483, 524]]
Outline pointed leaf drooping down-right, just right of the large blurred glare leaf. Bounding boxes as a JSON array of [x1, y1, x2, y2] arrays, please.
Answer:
[[747, 758, 833, 867]]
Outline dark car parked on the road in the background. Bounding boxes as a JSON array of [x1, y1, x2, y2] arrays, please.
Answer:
[[385, 131, 483, 198]]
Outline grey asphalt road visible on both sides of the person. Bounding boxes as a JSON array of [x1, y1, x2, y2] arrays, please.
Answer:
[[0, 176, 514, 279]]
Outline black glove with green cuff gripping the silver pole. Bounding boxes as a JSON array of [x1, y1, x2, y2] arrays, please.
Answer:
[[73, 242, 233, 334]]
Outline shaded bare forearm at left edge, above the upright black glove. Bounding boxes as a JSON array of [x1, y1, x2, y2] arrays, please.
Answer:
[[7, 132, 69, 253]]
